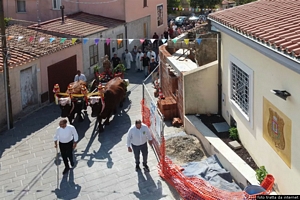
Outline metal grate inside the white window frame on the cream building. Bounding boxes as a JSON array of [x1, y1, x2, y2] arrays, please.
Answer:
[[231, 63, 250, 116]]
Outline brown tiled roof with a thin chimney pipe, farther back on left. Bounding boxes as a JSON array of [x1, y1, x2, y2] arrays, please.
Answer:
[[29, 12, 125, 37]]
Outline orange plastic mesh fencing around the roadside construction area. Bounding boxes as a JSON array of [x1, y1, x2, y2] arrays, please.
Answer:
[[141, 100, 274, 200]]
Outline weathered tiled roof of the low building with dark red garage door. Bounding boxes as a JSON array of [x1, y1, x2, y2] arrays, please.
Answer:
[[0, 25, 77, 71]]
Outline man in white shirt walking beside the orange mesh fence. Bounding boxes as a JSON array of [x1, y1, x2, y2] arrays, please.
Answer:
[[127, 120, 152, 172]]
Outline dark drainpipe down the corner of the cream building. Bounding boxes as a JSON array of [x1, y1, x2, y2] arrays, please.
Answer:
[[208, 20, 222, 115]]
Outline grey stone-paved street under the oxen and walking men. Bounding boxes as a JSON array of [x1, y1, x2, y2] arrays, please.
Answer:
[[0, 61, 180, 200]]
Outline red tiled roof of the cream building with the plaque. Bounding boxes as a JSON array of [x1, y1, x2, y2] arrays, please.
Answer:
[[209, 0, 300, 59]]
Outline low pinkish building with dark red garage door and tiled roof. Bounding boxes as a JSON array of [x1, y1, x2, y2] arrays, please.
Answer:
[[0, 25, 83, 127]]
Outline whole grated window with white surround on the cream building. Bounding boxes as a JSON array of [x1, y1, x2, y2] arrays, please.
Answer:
[[230, 56, 253, 123]]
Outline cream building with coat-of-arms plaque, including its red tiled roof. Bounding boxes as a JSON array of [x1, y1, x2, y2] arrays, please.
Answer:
[[209, 0, 300, 194]]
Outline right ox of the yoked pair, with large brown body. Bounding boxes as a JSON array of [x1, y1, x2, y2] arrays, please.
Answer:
[[90, 77, 127, 132]]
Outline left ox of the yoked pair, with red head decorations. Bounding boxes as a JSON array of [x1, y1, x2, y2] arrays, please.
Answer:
[[58, 81, 86, 124]]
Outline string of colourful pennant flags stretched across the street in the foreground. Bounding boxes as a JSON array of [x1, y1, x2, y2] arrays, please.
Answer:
[[7, 36, 204, 45]]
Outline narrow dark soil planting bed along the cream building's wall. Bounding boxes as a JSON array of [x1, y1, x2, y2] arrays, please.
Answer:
[[198, 114, 258, 170]]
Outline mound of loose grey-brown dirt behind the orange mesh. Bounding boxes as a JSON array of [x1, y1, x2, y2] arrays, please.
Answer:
[[166, 135, 206, 165]]
